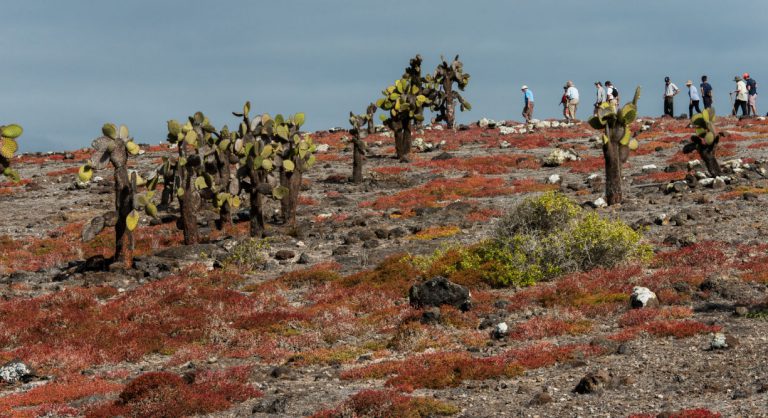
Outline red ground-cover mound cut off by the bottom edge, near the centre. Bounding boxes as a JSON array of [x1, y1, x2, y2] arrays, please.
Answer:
[[312, 390, 459, 418]]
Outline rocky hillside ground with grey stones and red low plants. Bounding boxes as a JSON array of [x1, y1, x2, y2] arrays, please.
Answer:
[[0, 118, 768, 417]]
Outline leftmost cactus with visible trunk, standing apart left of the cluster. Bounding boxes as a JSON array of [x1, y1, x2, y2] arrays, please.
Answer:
[[78, 123, 144, 262]]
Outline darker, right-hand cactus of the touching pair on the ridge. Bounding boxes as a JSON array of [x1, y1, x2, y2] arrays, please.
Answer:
[[426, 55, 472, 129]]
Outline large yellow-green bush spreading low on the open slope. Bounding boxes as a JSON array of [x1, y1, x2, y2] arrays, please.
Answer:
[[420, 192, 652, 287]]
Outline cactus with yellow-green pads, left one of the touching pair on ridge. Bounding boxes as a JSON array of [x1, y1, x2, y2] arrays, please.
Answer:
[[376, 55, 431, 162]]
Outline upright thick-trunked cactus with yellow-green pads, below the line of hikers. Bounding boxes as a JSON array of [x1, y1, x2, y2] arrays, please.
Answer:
[[589, 87, 640, 205]]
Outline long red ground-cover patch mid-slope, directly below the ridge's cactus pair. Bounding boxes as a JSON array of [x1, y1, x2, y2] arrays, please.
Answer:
[[360, 176, 513, 210]]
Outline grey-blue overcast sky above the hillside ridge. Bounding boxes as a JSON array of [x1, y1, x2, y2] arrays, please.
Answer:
[[0, 0, 768, 151]]
